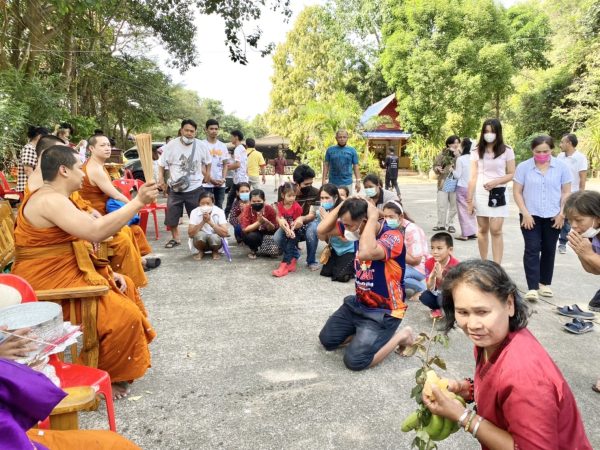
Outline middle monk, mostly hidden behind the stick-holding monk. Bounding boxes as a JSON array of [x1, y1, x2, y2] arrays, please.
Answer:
[[24, 135, 148, 287]]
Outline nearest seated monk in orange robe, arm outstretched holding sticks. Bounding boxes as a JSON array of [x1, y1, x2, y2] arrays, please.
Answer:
[[12, 145, 158, 397]]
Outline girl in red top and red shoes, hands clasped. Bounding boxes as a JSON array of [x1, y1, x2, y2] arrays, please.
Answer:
[[272, 183, 302, 277]]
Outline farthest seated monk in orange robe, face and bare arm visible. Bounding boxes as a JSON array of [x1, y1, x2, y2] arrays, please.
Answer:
[[80, 136, 152, 256]]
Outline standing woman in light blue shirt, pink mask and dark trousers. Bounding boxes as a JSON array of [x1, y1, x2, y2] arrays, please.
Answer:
[[513, 135, 571, 301]]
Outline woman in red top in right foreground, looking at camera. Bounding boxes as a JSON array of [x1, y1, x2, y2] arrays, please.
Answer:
[[423, 260, 592, 450]]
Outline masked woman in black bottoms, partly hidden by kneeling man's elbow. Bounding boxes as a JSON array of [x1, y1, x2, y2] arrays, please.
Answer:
[[315, 183, 355, 283]]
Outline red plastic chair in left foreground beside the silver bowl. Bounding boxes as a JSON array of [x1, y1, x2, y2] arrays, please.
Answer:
[[0, 274, 117, 432]]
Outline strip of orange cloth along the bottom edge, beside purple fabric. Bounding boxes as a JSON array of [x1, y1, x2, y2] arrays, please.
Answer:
[[27, 429, 141, 450]]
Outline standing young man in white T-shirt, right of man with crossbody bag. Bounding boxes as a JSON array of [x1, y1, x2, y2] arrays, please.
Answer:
[[202, 119, 229, 209]]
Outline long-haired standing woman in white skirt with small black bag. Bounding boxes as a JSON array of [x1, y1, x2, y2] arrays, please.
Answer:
[[467, 119, 515, 264]]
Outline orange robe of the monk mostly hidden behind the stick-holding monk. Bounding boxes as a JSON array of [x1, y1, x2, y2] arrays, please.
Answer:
[[69, 191, 152, 287]]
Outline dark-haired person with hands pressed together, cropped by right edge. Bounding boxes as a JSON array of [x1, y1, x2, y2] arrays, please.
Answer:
[[565, 191, 600, 393]]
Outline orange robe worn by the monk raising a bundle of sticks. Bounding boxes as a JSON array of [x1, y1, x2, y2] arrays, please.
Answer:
[[12, 193, 156, 382]]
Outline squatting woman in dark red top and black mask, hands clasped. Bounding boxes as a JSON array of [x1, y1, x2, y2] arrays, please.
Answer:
[[240, 189, 277, 259]]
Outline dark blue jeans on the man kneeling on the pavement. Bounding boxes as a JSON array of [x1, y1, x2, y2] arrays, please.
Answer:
[[319, 295, 401, 370]]
